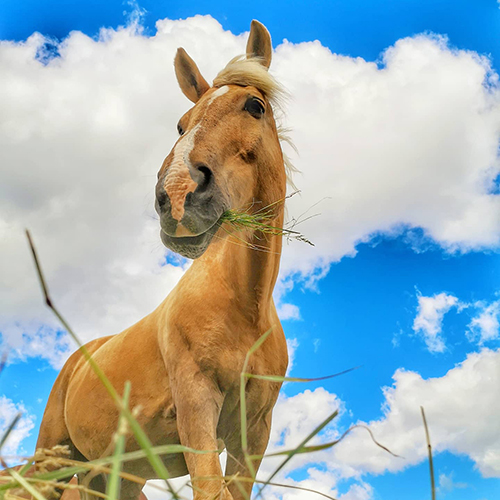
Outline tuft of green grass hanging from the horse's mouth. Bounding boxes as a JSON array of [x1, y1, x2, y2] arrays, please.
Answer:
[[220, 193, 314, 246]]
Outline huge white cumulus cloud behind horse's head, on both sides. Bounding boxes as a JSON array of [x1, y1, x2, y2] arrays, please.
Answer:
[[0, 16, 500, 366]]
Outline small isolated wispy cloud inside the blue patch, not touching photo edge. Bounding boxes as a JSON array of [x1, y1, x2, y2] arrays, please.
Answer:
[[413, 292, 460, 353]]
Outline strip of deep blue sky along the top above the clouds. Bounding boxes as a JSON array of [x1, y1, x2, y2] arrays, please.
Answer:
[[0, 0, 500, 68]]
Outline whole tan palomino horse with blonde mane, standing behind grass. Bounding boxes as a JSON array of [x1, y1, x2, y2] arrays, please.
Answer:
[[37, 21, 288, 500]]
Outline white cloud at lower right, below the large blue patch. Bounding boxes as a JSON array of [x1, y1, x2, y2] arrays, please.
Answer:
[[332, 349, 500, 477]]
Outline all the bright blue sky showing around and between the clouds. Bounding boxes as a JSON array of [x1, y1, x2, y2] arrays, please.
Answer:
[[0, 0, 500, 500]]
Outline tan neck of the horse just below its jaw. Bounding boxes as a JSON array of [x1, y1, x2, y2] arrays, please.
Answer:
[[188, 210, 283, 321]]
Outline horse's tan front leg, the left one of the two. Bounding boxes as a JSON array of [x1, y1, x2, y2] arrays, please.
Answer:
[[172, 363, 232, 500]]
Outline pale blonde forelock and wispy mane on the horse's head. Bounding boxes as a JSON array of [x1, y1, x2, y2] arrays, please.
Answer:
[[213, 56, 299, 190]]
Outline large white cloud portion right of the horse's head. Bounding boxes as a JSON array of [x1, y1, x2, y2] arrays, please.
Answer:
[[274, 35, 500, 282]]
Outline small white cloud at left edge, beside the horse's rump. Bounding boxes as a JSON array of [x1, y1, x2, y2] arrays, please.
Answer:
[[0, 396, 35, 463]]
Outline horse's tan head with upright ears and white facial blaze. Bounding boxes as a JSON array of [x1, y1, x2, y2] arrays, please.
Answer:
[[155, 21, 286, 259]]
